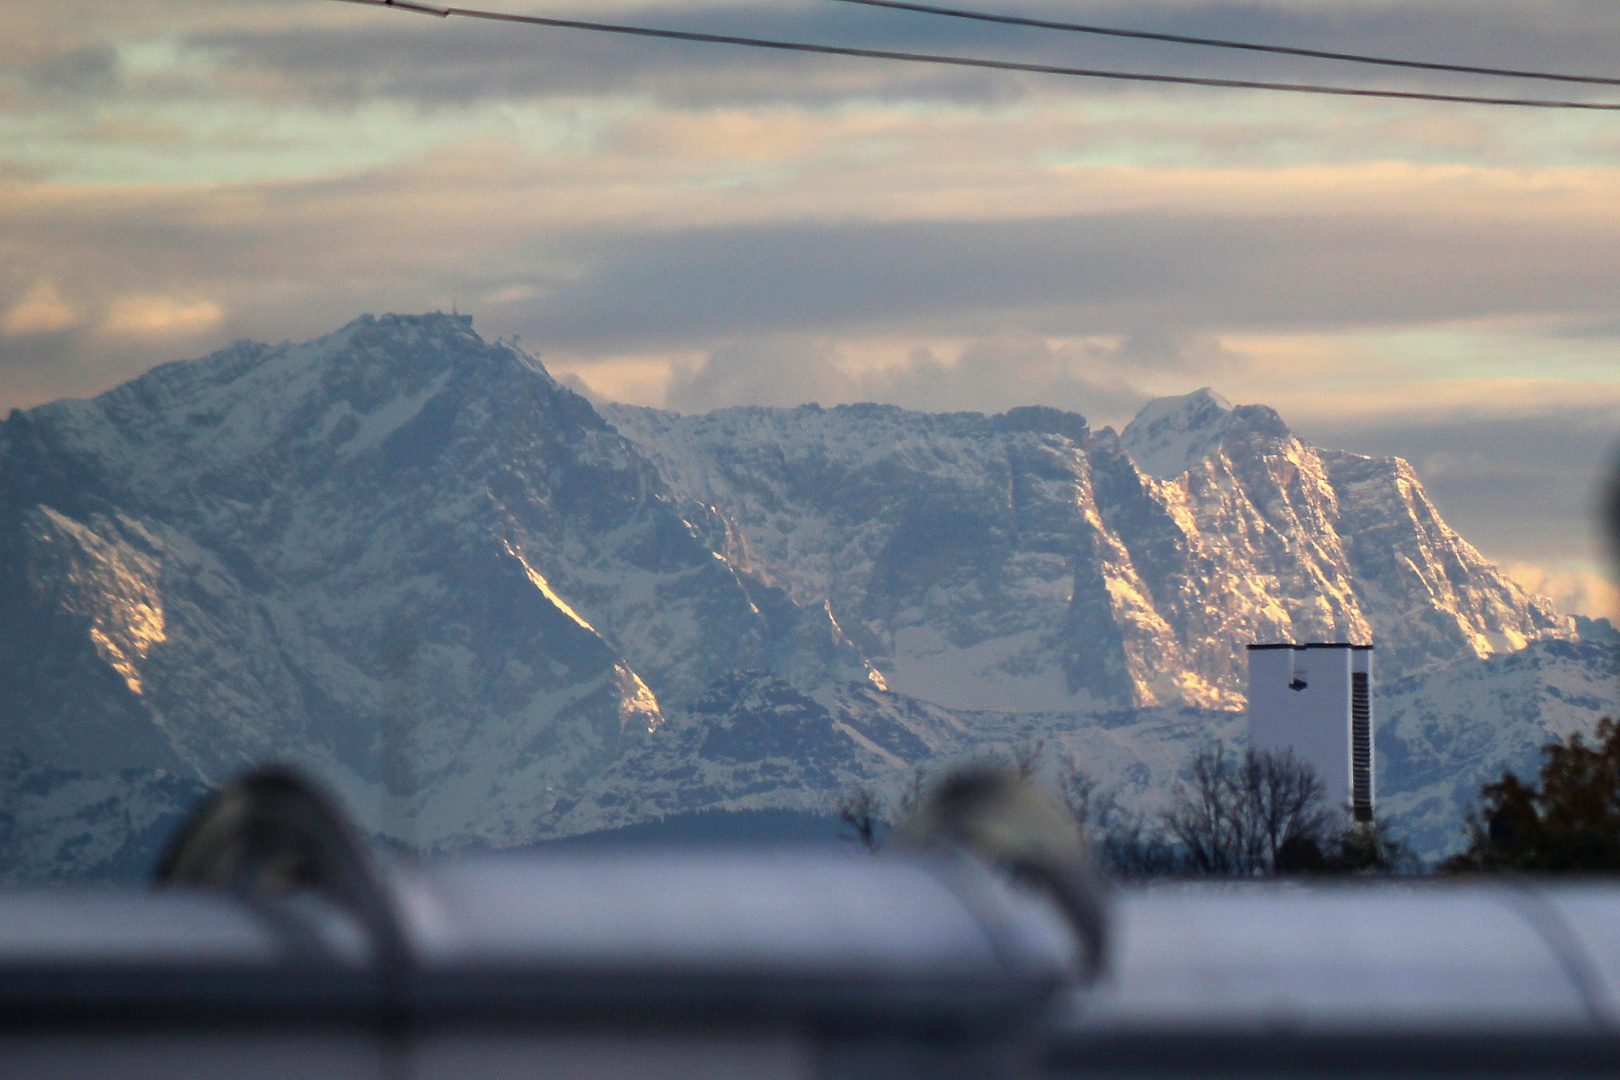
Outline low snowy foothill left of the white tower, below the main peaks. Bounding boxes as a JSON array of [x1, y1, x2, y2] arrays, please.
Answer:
[[564, 674, 1244, 831]]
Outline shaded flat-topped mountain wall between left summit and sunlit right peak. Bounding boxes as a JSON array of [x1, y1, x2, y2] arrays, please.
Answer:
[[604, 405, 1146, 709]]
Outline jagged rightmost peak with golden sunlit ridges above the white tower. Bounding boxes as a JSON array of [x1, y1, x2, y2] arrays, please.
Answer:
[[1121, 389, 1575, 680]]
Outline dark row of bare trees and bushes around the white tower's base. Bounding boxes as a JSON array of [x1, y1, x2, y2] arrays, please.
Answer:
[[836, 719, 1620, 878]]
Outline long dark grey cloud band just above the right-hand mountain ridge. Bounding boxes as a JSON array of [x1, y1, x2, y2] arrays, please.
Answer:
[[515, 214, 1620, 350]]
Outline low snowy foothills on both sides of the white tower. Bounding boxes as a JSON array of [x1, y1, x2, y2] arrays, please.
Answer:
[[550, 641, 1620, 863]]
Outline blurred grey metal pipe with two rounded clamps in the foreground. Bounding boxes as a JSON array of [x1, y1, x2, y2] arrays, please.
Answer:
[[0, 771, 1620, 1080]]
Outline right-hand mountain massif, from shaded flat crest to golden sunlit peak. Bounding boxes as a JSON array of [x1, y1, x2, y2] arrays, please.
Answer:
[[603, 390, 1573, 711]]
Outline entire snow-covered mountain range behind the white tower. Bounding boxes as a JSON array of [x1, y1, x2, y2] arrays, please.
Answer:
[[0, 316, 1612, 878]]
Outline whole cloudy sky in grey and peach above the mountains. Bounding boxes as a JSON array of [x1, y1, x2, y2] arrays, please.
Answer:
[[0, 0, 1620, 614]]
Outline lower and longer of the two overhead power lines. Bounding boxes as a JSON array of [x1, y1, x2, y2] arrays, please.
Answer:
[[332, 0, 1620, 112]]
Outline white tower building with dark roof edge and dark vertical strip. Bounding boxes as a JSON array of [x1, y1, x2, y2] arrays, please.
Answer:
[[1249, 643, 1374, 821]]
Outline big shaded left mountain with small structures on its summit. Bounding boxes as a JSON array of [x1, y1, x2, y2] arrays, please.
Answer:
[[0, 316, 865, 845]]
